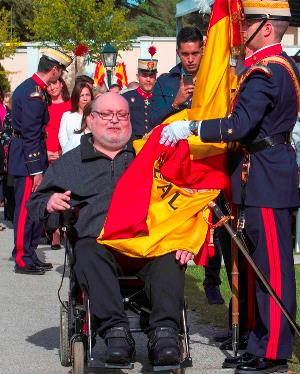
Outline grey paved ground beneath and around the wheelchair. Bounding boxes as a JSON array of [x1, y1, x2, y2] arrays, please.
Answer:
[[0, 209, 237, 374]]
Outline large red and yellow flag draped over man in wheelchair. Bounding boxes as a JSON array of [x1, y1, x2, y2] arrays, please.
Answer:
[[97, 0, 242, 265]]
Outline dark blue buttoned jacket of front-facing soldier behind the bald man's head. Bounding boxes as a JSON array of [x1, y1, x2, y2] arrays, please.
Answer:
[[122, 90, 152, 138]]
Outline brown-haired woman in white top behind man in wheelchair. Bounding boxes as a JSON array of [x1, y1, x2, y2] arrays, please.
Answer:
[[58, 82, 94, 153]]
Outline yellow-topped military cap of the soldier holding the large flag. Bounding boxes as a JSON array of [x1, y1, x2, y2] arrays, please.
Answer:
[[243, 0, 291, 21]]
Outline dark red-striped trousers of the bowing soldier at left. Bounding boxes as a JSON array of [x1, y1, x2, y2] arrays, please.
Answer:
[[12, 176, 43, 267]]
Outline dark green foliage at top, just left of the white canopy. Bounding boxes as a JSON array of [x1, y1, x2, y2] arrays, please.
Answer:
[[131, 0, 178, 36]]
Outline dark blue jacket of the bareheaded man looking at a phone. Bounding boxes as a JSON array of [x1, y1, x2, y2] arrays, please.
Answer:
[[150, 63, 190, 127]]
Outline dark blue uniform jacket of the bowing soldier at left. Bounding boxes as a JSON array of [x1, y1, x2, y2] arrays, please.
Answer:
[[8, 78, 49, 176]]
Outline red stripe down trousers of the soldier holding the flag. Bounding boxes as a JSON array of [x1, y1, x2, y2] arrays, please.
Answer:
[[261, 208, 282, 359]]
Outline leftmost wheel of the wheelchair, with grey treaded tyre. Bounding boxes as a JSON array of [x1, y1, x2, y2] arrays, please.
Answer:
[[59, 301, 71, 366]]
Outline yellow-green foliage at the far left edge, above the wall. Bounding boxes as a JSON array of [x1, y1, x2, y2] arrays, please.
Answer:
[[0, 8, 18, 60]]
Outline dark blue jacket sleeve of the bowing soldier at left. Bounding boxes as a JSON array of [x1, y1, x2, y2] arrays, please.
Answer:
[[22, 96, 48, 175]]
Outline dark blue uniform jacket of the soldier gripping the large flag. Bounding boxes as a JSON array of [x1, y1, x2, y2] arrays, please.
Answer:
[[200, 53, 299, 208]]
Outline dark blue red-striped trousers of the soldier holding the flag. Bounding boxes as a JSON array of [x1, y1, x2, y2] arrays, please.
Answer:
[[245, 207, 296, 359]]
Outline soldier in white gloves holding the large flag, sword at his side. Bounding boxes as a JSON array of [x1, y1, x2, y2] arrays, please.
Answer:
[[161, 0, 299, 374]]
